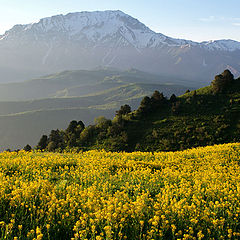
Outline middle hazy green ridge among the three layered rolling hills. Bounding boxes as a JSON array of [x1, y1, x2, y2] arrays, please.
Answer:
[[0, 83, 186, 115]]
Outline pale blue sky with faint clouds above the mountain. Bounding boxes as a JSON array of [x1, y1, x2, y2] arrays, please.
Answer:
[[0, 0, 240, 41]]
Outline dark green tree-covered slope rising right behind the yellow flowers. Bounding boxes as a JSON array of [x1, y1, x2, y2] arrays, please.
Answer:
[[36, 70, 240, 151]]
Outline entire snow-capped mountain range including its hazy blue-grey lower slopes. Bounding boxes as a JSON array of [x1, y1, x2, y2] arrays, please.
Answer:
[[0, 11, 240, 85]]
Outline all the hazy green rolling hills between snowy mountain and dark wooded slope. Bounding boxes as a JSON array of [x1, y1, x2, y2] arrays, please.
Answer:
[[0, 69, 187, 150]]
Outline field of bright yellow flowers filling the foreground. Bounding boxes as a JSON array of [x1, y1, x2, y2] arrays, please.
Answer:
[[0, 144, 240, 240]]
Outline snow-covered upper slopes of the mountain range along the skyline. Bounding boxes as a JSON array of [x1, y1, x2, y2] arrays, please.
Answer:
[[0, 10, 240, 51]]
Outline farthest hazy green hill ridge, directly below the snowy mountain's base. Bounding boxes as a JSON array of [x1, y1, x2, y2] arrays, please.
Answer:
[[0, 69, 188, 101]]
